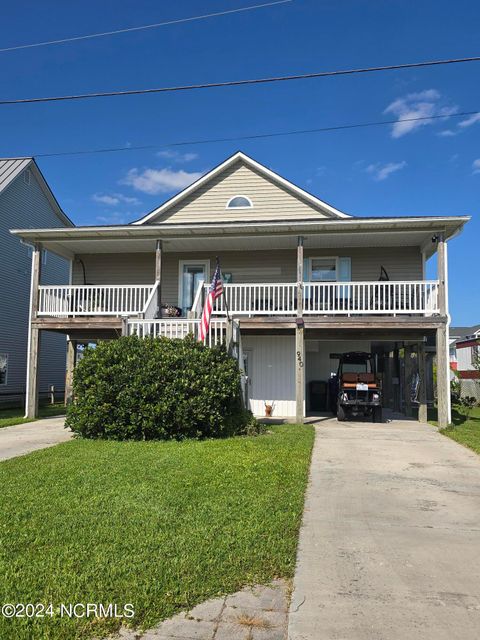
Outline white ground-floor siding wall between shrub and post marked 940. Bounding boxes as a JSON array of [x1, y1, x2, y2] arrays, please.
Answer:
[[242, 336, 296, 418]]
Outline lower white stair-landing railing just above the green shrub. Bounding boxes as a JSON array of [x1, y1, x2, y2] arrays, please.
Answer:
[[128, 318, 227, 347]]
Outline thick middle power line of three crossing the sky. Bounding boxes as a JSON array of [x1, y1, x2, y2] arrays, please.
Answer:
[[0, 56, 480, 105]]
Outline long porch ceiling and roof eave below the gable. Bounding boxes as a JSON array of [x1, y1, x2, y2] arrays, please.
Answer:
[[12, 216, 469, 258]]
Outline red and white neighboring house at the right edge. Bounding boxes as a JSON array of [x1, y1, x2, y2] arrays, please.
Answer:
[[450, 324, 480, 400]]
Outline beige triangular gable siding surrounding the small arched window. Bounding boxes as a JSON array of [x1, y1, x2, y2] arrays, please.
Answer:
[[151, 161, 334, 224]]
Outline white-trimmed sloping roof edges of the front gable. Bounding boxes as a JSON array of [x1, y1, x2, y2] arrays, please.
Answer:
[[132, 151, 352, 225]]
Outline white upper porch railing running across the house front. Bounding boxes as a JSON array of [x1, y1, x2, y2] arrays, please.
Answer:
[[38, 280, 439, 318]]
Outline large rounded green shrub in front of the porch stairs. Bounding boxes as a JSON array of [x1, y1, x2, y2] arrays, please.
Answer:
[[66, 336, 252, 440]]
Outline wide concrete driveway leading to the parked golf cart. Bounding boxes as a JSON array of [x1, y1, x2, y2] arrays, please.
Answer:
[[289, 420, 480, 640]]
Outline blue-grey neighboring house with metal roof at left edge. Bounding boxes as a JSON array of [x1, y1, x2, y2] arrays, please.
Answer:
[[0, 158, 72, 405]]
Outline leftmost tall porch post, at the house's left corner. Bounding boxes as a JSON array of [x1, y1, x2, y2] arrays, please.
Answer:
[[25, 244, 42, 419]]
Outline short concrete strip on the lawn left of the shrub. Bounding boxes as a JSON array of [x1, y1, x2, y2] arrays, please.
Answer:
[[0, 417, 72, 461]]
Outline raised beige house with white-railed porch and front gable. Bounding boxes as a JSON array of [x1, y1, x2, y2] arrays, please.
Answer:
[[12, 152, 469, 425]]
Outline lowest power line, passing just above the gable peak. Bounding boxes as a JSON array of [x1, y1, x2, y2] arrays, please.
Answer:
[[34, 111, 480, 158]]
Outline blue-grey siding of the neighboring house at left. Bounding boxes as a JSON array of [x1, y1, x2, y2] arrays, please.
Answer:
[[0, 172, 68, 399]]
